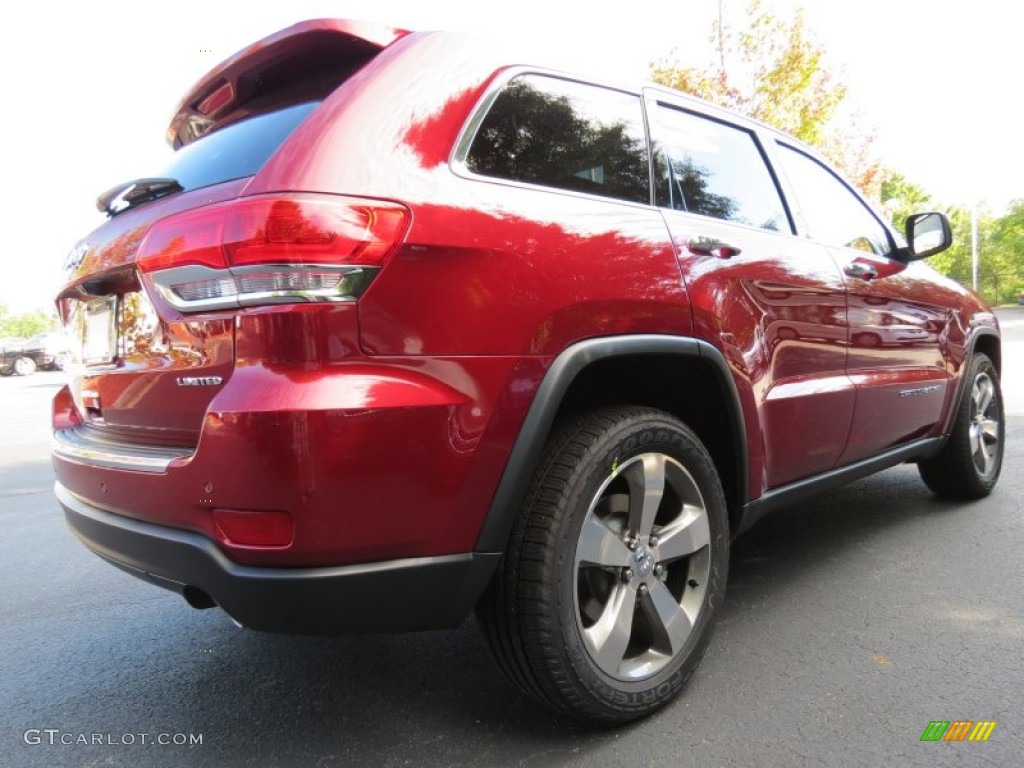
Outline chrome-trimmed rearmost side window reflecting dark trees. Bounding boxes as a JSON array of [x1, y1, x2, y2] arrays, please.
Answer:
[[466, 75, 650, 203]]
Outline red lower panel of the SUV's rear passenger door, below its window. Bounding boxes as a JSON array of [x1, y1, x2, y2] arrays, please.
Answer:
[[666, 207, 855, 489]]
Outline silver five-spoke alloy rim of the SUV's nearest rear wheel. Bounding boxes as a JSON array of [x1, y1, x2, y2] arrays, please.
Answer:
[[575, 454, 711, 680]]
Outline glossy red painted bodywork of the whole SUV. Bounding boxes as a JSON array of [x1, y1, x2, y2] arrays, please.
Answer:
[[53, 22, 994, 589]]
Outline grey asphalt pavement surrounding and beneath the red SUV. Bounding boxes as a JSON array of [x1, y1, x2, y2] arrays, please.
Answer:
[[0, 308, 1024, 768]]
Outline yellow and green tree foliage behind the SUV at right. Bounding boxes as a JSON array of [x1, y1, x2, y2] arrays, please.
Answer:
[[650, 0, 1024, 304]]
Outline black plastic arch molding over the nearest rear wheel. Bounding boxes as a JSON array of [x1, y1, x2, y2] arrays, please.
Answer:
[[475, 334, 749, 552]]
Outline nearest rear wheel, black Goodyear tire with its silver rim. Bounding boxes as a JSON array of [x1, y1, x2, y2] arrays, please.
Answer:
[[477, 407, 729, 725]]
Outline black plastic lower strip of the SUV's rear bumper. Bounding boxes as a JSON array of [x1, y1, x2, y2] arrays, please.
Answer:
[[55, 483, 500, 635]]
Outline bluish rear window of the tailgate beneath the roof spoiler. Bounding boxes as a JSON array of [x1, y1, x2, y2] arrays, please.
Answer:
[[160, 101, 319, 189]]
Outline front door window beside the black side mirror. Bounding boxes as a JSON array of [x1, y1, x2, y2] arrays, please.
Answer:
[[778, 144, 892, 256]]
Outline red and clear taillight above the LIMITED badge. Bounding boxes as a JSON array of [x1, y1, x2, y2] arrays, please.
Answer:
[[136, 195, 410, 311]]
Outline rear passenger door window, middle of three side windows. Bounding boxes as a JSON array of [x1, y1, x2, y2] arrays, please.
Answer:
[[651, 103, 791, 231]]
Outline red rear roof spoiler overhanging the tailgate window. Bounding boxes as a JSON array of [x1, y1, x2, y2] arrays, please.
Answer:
[[167, 18, 409, 150]]
